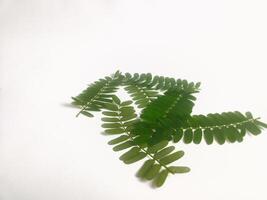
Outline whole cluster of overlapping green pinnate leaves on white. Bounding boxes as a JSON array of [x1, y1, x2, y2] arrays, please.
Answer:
[[72, 71, 267, 187]]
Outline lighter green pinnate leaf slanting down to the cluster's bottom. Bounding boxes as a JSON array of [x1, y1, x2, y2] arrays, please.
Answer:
[[102, 96, 191, 185]]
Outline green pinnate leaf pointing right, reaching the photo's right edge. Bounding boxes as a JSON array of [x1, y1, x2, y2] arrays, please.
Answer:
[[169, 111, 266, 145]]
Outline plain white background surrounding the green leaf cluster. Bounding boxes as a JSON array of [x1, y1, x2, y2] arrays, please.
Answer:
[[0, 0, 267, 200]]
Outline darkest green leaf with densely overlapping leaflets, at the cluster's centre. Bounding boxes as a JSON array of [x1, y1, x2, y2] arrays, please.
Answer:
[[131, 89, 198, 144]]
